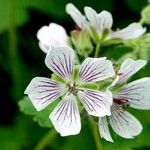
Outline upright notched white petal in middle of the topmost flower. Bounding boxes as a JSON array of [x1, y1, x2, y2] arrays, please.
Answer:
[[84, 7, 113, 32]]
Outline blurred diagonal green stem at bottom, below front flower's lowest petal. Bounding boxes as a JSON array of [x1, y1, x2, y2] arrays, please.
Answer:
[[34, 129, 57, 150]]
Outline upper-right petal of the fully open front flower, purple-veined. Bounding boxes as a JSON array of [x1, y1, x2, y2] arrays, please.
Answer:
[[78, 57, 115, 84]]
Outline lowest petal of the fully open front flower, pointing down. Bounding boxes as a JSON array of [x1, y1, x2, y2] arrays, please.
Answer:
[[49, 94, 81, 136]]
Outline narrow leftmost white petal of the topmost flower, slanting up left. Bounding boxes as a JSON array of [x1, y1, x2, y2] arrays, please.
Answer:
[[66, 3, 88, 29]]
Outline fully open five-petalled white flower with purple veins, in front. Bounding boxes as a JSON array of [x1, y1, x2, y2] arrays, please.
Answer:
[[25, 46, 115, 136]]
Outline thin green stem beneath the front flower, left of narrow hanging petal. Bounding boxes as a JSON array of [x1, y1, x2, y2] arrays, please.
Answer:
[[90, 118, 103, 150]]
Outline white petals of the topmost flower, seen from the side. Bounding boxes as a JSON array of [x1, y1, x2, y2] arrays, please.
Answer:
[[66, 3, 146, 39]]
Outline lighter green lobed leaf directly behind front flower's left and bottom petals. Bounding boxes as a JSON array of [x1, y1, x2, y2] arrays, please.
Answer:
[[19, 97, 58, 128]]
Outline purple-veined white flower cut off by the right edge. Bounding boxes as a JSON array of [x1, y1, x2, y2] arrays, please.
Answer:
[[99, 59, 150, 142]]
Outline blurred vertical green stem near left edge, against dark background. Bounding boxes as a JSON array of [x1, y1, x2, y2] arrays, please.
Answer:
[[8, 0, 22, 99]]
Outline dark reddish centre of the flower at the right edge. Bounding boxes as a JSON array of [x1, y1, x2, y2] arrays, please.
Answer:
[[113, 98, 130, 110]]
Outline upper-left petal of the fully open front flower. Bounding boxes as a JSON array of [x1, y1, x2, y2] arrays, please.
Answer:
[[45, 46, 75, 81]]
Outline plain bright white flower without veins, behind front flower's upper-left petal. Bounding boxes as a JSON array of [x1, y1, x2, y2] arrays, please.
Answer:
[[37, 23, 68, 53]]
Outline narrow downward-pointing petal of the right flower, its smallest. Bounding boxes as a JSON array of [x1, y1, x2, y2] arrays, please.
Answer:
[[99, 117, 113, 142]]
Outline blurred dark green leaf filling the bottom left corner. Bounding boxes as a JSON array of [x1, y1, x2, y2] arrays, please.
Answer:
[[0, 112, 48, 150]]
